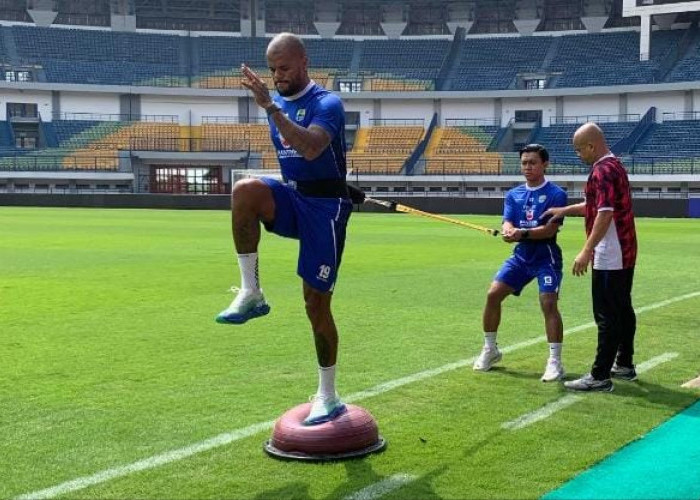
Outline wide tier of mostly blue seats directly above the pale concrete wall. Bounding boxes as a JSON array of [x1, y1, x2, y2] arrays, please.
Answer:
[[5, 25, 700, 91]]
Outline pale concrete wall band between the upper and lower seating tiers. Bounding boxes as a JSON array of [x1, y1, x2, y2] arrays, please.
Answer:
[[0, 81, 700, 126]]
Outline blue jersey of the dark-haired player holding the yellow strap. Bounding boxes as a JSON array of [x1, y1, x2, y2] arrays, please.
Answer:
[[503, 181, 567, 265]]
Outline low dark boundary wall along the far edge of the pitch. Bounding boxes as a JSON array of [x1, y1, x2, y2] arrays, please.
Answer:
[[0, 193, 688, 217]]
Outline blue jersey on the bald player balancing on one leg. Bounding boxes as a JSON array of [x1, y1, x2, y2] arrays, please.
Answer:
[[268, 81, 347, 181]]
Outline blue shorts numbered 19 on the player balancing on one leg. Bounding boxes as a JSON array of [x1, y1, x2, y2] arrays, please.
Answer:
[[261, 177, 352, 292]]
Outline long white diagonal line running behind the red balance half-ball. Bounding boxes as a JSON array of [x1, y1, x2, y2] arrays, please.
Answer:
[[16, 291, 700, 500]]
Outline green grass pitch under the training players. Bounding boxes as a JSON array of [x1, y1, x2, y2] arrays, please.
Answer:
[[0, 208, 700, 499]]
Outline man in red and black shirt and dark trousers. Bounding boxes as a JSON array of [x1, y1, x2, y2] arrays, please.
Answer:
[[545, 123, 637, 392]]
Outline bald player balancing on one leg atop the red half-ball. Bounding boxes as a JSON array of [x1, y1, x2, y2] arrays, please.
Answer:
[[216, 33, 352, 425]]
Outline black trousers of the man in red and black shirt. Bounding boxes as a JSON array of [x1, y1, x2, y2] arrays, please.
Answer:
[[591, 267, 637, 380]]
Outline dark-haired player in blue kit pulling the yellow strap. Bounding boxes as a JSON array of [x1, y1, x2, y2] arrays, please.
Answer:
[[474, 144, 566, 382]]
